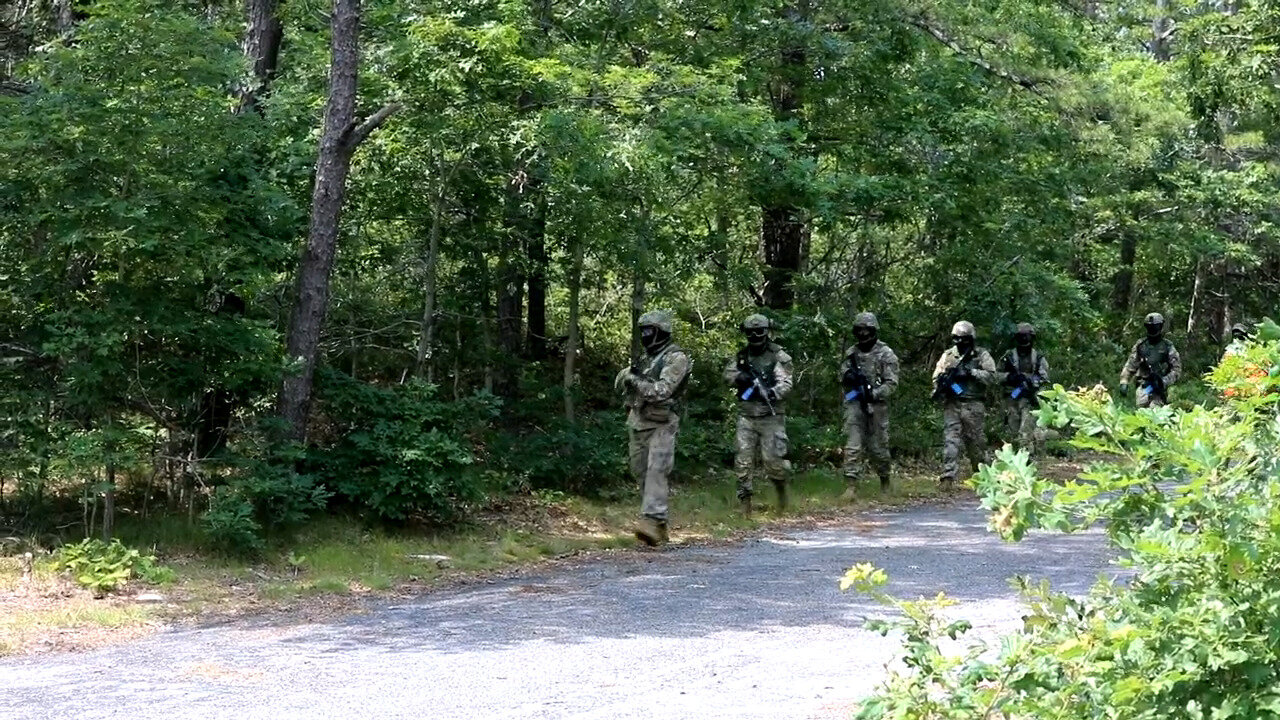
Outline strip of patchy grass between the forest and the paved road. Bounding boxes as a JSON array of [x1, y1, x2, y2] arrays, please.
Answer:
[[0, 461, 937, 655]]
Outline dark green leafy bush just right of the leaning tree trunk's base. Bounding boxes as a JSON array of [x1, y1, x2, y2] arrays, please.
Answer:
[[307, 372, 495, 523]]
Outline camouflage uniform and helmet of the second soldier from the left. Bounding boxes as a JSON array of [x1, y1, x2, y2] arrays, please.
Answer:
[[724, 315, 791, 500]]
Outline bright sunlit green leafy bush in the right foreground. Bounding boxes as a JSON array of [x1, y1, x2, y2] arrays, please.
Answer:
[[842, 325, 1280, 720]]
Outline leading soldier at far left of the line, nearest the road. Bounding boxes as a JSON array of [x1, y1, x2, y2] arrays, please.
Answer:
[[614, 313, 692, 546]]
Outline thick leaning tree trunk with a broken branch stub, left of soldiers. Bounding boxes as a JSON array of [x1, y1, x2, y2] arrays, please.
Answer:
[[278, 0, 399, 442]]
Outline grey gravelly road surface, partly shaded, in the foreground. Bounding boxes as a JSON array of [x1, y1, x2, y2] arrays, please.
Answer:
[[0, 498, 1112, 720]]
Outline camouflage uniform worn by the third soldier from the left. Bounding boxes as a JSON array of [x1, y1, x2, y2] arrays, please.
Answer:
[[840, 333, 897, 486]]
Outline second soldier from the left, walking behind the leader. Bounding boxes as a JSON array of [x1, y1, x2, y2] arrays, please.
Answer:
[[724, 315, 791, 516]]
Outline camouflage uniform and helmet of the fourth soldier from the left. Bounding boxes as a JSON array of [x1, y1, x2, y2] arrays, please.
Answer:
[[933, 323, 998, 484]]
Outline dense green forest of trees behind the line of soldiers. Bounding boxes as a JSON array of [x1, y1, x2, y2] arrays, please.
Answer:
[[0, 0, 1280, 551]]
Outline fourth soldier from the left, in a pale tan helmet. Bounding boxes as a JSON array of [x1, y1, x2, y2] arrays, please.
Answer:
[[933, 320, 997, 489]]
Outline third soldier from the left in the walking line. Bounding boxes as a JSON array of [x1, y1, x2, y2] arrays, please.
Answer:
[[840, 313, 897, 501]]
